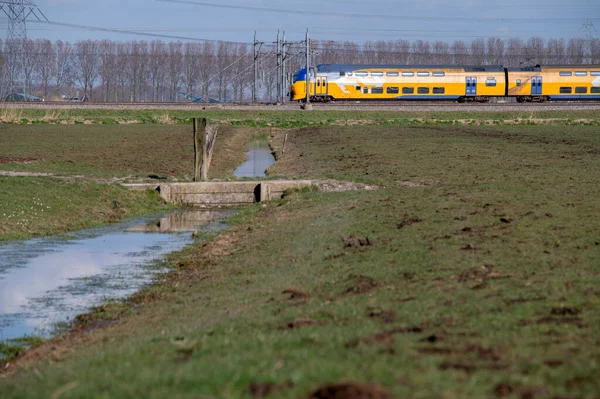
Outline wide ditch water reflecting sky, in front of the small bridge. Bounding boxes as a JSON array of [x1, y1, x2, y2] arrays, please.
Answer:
[[0, 210, 230, 341]]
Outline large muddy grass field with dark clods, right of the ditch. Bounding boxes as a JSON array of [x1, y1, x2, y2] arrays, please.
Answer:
[[0, 117, 600, 399]]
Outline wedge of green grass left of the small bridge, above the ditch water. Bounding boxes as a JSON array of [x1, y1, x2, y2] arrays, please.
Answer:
[[0, 180, 171, 241]]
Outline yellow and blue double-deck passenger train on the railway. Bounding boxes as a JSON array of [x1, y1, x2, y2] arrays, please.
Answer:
[[290, 64, 600, 102]]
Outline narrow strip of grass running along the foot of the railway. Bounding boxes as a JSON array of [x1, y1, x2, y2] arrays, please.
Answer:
[[0, 107, 600, 128]]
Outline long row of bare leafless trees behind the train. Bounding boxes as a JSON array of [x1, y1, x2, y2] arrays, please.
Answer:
[[0, 37, 600, 102]]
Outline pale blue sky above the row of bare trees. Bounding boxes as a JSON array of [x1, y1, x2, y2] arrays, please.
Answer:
[[0, 0, 600, 43]]
